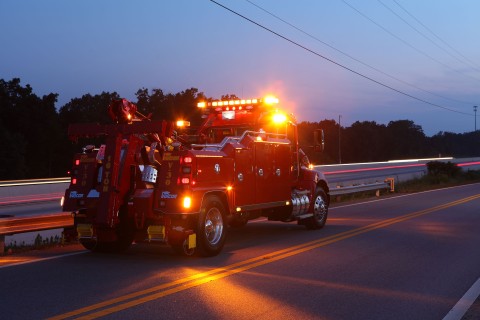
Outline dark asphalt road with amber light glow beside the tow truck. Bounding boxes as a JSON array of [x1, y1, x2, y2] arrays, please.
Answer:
[[0, 184, 480, 320]]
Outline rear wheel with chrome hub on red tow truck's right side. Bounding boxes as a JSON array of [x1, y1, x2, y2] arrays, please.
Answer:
[[197, 196, 227, 257]]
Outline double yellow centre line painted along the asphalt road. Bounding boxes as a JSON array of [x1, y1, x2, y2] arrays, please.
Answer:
[[49, 194, 480, 320]]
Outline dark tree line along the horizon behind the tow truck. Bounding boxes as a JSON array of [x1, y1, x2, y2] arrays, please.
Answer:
[[0, 78, 480, 180]]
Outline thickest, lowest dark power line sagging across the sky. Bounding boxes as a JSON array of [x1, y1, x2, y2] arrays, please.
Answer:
[[210, 0, 471, 116]]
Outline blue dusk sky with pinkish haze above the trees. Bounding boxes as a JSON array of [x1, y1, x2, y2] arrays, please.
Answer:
[[0, 0, 480, 136]]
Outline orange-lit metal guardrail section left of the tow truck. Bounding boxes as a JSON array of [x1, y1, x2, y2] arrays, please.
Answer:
[[0, 212, 73, 254]]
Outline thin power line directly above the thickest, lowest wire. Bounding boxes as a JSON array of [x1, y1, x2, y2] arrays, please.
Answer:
[[245, 0, 474, 105]]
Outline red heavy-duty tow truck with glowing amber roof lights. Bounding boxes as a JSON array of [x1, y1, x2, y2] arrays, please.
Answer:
[[63, 97, 330, 256]]
